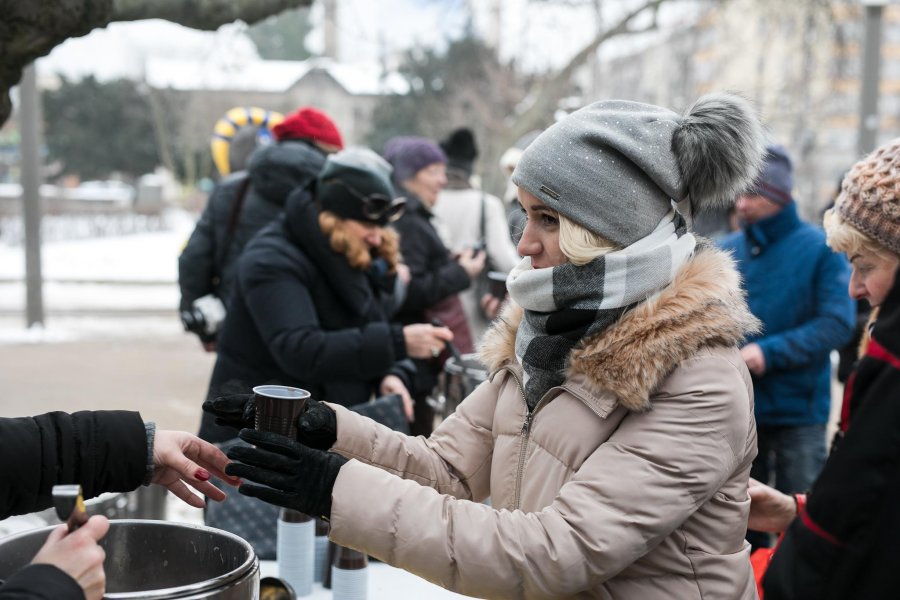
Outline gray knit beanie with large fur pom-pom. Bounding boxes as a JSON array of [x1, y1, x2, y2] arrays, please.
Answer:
[[512, 94, 765, 246]]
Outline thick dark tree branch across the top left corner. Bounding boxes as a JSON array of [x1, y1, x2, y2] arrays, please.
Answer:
[[0, 0, 313, 125]]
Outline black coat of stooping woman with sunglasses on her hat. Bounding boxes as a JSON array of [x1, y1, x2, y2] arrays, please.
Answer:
[[200, 190, 412, 442]]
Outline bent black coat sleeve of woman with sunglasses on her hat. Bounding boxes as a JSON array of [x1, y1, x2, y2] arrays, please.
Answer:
[[244, 252, 402, 383]]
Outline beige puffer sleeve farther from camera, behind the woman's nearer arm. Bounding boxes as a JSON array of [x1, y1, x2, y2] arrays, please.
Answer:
[[330, 382, 497, 501]]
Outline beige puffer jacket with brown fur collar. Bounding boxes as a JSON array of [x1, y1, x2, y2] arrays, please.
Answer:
[[331, 249, 757, 600]]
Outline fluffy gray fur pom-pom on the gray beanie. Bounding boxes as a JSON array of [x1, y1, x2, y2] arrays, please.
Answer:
[[672, 94, 768, 213]]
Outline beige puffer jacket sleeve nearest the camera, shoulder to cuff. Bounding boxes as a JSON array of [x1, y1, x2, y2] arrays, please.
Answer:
[[331, 358, 752, 599]]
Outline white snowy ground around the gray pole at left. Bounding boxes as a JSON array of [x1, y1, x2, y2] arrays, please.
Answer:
[[0, 211, 194, 344]]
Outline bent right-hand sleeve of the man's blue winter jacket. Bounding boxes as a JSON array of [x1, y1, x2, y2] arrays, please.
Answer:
[[757, 248, 856, 371]]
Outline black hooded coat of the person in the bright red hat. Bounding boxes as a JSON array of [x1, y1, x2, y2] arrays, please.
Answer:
[[178, 140, 325, 330]]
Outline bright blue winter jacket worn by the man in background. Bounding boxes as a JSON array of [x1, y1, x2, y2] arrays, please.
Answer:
[[719, 203, 854, 426]]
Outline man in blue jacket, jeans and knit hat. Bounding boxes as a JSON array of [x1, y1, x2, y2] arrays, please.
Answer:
[[721, 145, 854, 542]]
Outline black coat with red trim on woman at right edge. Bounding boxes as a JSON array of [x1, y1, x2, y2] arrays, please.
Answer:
[[763, 274, 900, 600]]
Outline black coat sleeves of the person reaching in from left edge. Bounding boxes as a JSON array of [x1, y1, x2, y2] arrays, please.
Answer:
[[0, 411, 147, 600]]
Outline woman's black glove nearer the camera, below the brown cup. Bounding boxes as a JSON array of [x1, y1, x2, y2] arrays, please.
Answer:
[[225, 429, 347, 519]]
